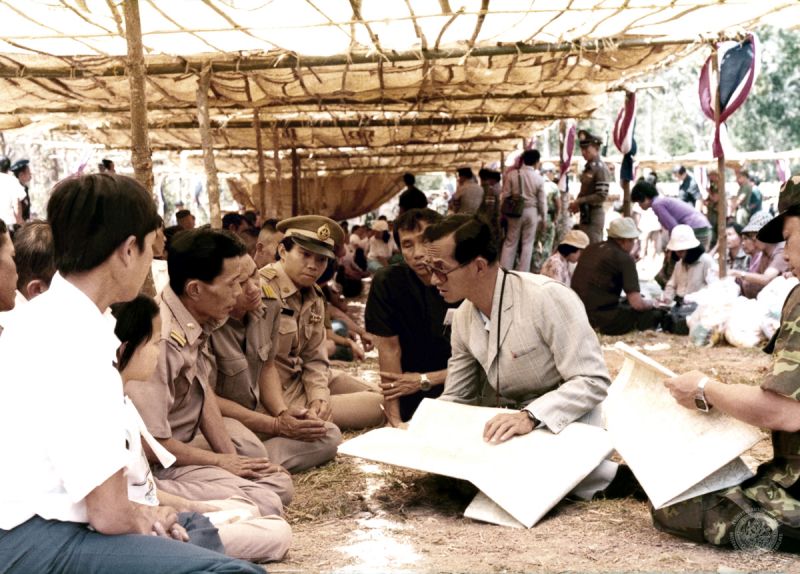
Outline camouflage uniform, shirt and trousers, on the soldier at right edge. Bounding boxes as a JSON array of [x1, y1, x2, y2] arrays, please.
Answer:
[[652, 286, 800, 550]]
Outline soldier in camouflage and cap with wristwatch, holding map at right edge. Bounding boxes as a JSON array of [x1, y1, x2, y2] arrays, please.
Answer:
[[651, 176, 800, 553]]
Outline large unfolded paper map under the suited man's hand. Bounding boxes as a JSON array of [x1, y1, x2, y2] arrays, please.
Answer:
[[339, 399, 612, 528]]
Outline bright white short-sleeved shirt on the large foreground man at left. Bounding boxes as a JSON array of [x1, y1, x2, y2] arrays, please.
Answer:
[[0, 273, 128, 530]]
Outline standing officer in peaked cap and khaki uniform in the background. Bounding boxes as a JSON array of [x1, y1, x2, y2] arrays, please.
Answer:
[[569, 130, 612, 243]]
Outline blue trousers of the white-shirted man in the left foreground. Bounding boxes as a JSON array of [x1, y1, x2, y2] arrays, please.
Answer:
[[0, 516, 264, 574]]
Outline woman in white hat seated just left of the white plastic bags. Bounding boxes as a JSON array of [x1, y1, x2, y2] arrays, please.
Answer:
[[663, 225, 714, 303]]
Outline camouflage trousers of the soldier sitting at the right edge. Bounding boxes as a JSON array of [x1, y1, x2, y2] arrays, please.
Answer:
[[650, 487, 800, 553]]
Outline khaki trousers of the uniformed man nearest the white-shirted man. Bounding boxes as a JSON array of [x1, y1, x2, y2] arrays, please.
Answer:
[[153, 464, 294, 516]]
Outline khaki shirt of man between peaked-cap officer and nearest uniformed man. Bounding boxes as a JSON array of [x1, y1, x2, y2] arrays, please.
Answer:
[[209, 283, 281, 410]]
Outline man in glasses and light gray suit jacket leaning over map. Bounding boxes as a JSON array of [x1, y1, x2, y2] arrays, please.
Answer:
[[425, 215, 616, 498]]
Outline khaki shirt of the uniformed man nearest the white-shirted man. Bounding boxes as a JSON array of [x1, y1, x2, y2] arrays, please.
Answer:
[[130, 286, 219, 442]]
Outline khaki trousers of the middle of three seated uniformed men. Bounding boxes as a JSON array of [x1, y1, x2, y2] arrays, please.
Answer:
[[197, 417, 342, 473]]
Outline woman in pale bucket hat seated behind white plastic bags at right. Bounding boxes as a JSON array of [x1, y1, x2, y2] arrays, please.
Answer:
[[731, 211, 788, 299]]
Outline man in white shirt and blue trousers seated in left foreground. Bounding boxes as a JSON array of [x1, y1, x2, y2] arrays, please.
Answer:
[[0, 174, 260, 574]]
